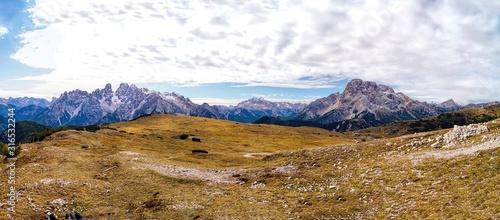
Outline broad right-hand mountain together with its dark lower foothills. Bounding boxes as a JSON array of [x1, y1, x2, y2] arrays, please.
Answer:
[[257, 79, 496, 131]]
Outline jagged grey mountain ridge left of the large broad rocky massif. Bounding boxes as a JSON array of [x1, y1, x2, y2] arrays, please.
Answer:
[[3, 83, 305, 127]]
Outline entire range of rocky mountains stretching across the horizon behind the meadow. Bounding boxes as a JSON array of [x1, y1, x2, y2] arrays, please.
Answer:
[[0, 79, 496, 131]]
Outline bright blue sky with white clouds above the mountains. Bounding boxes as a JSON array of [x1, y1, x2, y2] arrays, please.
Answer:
[[0, 0, 500, 105]]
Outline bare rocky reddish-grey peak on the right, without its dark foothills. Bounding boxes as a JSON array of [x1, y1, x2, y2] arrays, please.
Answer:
[[297, 79, 447, 125]]
